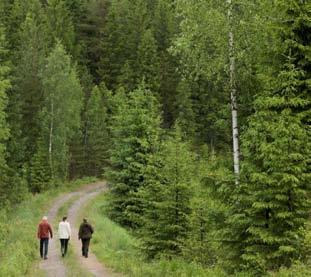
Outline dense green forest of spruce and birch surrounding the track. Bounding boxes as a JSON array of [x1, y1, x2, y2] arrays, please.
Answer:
[[0, 0, 311, 276]]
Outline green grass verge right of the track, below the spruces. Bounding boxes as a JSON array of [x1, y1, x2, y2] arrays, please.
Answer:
[[81, 194, 227, 277]]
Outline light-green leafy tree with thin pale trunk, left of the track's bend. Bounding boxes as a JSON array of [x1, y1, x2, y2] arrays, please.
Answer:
[[32, 43, 83, 182]]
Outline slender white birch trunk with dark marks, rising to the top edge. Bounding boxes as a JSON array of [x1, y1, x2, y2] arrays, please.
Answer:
[[227, 0, 240, 178]]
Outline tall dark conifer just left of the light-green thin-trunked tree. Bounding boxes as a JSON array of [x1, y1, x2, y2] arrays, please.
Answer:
[[9, 3, 48, 170]]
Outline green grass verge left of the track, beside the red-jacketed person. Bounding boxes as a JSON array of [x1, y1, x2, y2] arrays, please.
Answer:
[[0, 178, 95, 277]]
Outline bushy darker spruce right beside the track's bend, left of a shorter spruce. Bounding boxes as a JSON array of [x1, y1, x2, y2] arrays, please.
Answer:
[[107, 85, 161, 227]]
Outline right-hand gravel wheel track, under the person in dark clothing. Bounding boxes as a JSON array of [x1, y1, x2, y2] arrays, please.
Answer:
[[68, 185, 112, 277]]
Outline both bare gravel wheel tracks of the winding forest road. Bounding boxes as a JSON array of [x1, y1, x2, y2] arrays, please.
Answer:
[[39, 182, 115, 277]]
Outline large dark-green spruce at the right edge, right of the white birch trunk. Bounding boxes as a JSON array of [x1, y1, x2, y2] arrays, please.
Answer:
[[228, 0, 311, 272]]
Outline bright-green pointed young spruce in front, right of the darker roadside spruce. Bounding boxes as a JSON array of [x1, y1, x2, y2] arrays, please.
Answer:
[[138, 128, 195, 258]]
